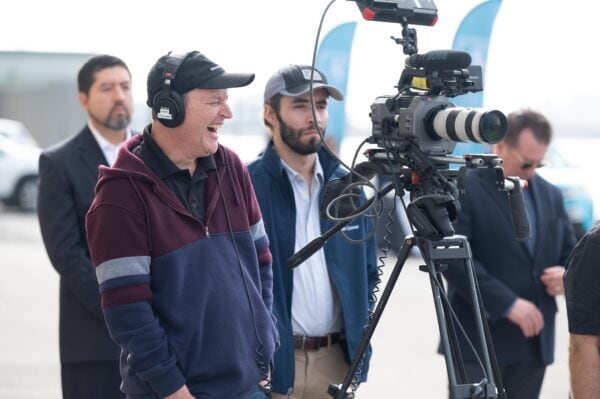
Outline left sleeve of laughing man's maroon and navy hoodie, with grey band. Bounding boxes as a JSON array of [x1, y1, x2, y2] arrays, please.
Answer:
[[86, 179, 185, 397]]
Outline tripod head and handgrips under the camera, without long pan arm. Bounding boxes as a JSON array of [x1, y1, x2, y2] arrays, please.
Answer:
[[324, 140, 530, 241]]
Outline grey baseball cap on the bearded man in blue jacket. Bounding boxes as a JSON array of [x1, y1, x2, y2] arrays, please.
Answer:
[[264, 65, 344, 104]]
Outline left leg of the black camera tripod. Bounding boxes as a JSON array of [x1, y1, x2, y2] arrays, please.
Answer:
[[327, 236, 415, 399]]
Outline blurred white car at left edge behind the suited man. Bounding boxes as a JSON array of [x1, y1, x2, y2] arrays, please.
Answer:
[[0, 135, 42, 211]]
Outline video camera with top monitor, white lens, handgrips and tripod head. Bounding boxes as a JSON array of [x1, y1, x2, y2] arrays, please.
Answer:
[[336, 0, 516, 240]]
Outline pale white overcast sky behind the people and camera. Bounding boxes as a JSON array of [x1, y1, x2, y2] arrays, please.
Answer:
[[0, 0, 600, 134]]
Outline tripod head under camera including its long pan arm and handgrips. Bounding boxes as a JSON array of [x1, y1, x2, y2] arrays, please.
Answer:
[[287, 140, 531, 268]]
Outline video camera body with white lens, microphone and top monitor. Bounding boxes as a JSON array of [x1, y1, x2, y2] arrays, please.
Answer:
[[356, 0, 507, 155]]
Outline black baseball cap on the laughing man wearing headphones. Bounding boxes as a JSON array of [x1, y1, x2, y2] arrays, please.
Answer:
[[147, 51, 254, 107]]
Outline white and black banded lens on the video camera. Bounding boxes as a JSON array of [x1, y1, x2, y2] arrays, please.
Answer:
[[428, 107, 508, 144]]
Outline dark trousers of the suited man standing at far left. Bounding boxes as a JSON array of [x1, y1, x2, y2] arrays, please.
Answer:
[[61, 361, 125, 399]]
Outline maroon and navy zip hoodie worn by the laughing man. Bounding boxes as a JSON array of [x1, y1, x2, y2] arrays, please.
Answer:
[[86, 135, 278, 399]]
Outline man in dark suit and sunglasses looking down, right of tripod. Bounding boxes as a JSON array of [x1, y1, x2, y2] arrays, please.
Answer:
[[445, 110, 575, 399]]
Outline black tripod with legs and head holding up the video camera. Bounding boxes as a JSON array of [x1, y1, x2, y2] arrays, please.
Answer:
[[328, 148, 520, 399]]
